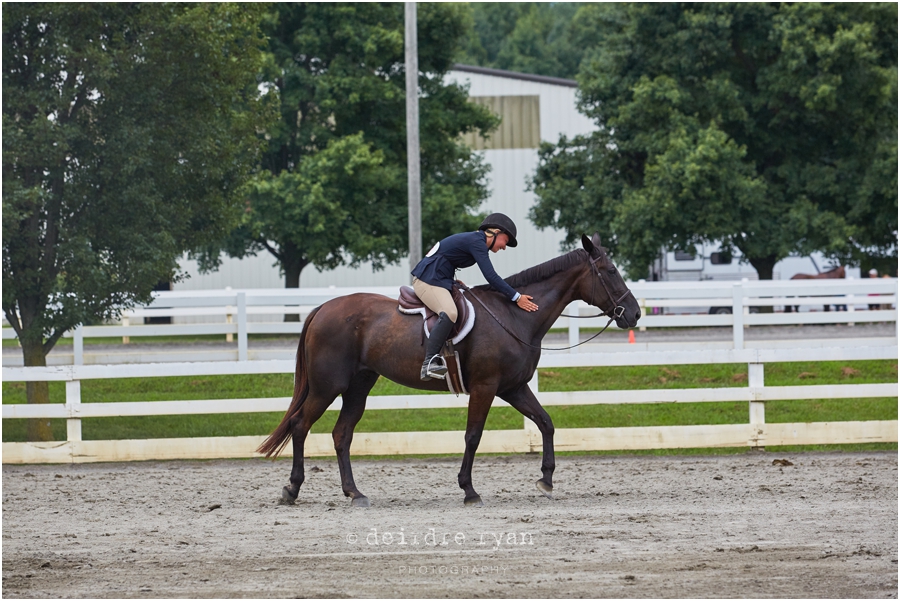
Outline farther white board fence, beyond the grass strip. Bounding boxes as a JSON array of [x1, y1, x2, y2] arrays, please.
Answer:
[[3, 278, 897, 365]]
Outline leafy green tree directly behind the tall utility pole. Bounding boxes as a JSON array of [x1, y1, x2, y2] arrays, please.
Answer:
[[200, 3, 497, 288]]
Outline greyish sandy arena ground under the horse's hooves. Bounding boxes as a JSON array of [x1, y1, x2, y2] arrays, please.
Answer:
[[2, 452, 898, 598]]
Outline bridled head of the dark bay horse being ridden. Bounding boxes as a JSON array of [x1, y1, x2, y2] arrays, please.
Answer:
[[579, 233, 641, 330]]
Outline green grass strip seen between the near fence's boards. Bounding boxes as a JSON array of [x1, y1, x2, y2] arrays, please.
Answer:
[[3, 361, 897, 454]]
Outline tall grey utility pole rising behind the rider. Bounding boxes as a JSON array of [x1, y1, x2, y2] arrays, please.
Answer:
[[404, 2, 422, 280]]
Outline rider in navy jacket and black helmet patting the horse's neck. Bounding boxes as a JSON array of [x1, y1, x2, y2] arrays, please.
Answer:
[[412, 213, 538, 380]]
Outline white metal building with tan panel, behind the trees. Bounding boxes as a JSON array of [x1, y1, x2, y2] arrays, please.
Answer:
[[174, 65, 594, 290]]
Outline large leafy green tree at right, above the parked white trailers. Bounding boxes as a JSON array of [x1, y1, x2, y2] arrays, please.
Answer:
[[532, 3, 897, 279]]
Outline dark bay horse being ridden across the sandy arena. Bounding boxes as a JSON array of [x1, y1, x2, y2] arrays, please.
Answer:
[[257, 233, 641, 507]]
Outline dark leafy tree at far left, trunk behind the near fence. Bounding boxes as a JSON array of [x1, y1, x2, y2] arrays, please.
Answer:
[[3, 3, 274, 440]]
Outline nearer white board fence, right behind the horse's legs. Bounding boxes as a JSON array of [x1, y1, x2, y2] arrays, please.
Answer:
[[3, 339, 898, 463]]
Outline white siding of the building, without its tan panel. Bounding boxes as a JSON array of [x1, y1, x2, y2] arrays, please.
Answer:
[[174, 71, 594, 290]]
